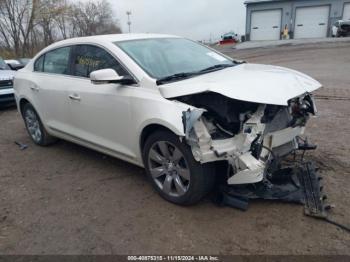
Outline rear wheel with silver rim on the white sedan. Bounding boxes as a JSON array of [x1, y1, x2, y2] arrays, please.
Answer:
[[22, 103, 57, 146]]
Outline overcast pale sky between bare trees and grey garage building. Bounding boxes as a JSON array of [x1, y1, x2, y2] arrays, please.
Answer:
[[110, 0, 245, 41]]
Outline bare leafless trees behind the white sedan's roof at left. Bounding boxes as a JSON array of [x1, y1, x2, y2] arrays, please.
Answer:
[[0, 0, 121, 57]]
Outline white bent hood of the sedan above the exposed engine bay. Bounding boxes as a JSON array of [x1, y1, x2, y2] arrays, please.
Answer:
[[159, 64, 322, 105]]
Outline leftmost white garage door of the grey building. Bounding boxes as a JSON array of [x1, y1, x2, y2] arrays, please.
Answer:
[[250, 10, 282, 40]]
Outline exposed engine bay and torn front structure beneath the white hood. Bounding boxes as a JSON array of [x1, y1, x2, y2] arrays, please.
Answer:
[[177, 93, 316, 184]]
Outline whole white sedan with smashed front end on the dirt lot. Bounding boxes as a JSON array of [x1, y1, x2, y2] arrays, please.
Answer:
[[14, 34, 321, 205]]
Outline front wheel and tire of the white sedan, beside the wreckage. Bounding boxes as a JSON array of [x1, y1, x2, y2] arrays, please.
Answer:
[[143, 131, 215, 205]]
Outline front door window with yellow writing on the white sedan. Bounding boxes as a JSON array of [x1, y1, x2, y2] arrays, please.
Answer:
[[73, 45, 128, 77]]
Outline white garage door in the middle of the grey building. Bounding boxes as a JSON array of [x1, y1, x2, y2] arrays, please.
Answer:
[[294, 6, 329, 38]]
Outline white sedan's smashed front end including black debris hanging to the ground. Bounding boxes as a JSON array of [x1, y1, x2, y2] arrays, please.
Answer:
[[176, 92, 324, 214]]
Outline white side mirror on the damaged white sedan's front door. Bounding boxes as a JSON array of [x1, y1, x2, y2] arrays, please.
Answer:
[[90, 68, 135, 85]]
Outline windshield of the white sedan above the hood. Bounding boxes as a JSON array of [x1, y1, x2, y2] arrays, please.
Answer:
[[115, 38, 233, 79]]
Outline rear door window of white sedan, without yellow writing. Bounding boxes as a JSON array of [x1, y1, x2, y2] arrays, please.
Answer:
[[43, 47, 71, 75]]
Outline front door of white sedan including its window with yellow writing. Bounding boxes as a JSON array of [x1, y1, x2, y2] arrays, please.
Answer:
[[67, 45, 139, 158]]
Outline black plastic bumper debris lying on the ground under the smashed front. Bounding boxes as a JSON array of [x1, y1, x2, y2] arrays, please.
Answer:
[[216, 162, 327, 217]]
